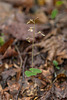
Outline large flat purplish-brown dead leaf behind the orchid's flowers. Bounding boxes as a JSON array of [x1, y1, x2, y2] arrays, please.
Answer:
[[3, 22, 37, 41]]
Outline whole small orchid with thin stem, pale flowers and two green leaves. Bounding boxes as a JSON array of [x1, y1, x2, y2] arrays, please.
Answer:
[[25, 18, 45, 77]]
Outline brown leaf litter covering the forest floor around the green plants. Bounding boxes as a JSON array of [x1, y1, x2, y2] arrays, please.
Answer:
[[0, 0, 67, 100]]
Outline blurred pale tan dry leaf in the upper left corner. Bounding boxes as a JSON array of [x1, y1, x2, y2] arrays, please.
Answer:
[[0, 0, 15, 24]]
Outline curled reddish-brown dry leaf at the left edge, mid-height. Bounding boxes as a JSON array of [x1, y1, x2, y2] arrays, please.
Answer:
[[0, 38, 18, 59]]
